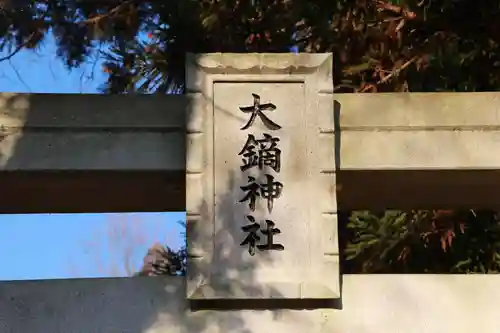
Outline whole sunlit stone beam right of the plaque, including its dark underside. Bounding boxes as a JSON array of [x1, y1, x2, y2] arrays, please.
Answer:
[[331, 92, 500, 210]]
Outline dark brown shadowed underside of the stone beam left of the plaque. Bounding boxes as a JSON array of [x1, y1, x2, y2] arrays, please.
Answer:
[[0, 170, 186, 214]]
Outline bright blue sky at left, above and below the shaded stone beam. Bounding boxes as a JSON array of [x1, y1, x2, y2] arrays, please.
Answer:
[[0, 32, 185, 280]]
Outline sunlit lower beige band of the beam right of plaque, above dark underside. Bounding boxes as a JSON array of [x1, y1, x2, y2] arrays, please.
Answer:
[[339, 129, 500, 170]]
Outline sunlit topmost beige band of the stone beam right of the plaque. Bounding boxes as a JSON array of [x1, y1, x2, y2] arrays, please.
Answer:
[[335, 92, 500, 130]]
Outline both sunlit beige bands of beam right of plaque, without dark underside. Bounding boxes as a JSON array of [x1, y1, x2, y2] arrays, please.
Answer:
[[335, 93, 500, 170]]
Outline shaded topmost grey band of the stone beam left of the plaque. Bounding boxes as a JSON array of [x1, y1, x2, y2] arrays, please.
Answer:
[[0, 93, 186, 130]]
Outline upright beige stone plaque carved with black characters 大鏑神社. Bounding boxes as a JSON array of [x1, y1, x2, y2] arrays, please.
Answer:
[[186, 53, 340, 299]]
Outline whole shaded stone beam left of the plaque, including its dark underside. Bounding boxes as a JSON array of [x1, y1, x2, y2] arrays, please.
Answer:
[[0, 93, 191, 213]]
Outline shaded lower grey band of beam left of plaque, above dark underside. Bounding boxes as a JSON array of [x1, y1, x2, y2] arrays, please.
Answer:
[[0, 129, 186, 171]]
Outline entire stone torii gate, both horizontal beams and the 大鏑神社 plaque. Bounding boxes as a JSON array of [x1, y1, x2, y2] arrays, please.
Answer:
[[0, 54, 500, 333]]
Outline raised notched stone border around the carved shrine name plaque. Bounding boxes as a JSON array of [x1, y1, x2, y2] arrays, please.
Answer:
[[186, 53, 340, 300]]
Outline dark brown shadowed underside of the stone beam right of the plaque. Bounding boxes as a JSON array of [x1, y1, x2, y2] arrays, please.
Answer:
[[337, 170, 500, 211]]
